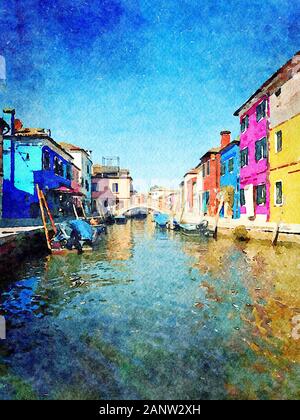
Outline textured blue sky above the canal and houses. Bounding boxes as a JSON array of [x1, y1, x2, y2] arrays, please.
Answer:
[[0, 0, 300, 189]]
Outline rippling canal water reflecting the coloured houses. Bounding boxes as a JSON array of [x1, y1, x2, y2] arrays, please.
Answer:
[[0, 220, 300, 399]]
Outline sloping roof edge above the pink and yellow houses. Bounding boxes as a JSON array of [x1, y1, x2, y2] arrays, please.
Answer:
[[233, 51, 300, 116]]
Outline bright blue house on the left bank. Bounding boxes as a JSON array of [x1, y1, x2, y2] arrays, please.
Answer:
[[2, 129, 73, 219]]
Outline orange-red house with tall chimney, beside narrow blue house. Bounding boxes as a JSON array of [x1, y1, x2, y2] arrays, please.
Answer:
[[201, 131, 230, 216]]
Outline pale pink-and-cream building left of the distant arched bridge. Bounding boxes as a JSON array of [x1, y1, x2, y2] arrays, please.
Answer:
[[92, 160, 133, 213]]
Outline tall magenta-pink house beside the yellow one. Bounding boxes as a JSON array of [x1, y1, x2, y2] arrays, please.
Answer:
[[234, 94, 270, 221]]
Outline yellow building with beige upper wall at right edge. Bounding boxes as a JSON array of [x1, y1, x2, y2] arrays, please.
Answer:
[[269, 53, 300, 224]]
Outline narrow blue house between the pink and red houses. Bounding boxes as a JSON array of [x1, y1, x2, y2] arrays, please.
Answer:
[[220, 140, 240, 219]]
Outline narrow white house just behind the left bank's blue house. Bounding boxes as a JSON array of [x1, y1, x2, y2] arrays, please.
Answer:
[[60, 142, 93, 213]]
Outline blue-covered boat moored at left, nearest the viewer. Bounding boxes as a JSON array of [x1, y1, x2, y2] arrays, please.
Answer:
[[50, 219, 105, 254]]
